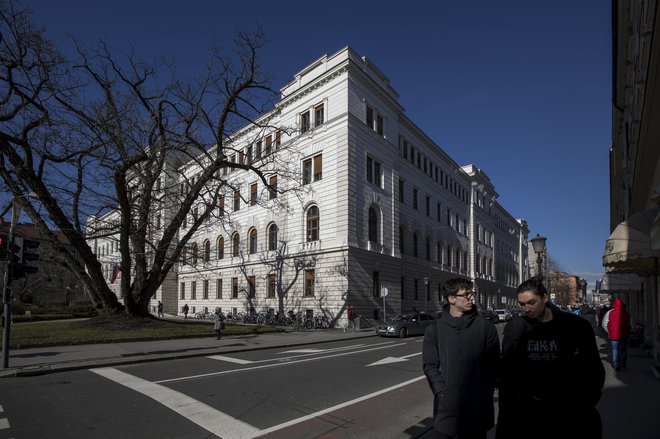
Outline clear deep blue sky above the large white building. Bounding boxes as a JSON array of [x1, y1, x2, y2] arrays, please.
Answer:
[[24, 0, 611, 287]]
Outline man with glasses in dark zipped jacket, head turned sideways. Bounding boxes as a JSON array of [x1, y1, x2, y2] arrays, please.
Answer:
[[422, 278, 500, 439]]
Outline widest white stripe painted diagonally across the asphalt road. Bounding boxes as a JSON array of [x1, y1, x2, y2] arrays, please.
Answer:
[[90, 367, 259, 439]]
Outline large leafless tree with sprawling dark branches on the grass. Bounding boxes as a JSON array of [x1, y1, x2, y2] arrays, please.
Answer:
[[0, 1, 298, 315]]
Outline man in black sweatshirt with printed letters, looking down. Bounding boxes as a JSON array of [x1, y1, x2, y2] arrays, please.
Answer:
[[496, 277, 605, 439]]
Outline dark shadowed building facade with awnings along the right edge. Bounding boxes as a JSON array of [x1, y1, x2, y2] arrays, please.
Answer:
[[603, 0, 660, 377]]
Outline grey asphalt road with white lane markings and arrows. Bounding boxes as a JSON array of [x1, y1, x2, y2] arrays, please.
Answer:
[[0, 337, 438, 439]]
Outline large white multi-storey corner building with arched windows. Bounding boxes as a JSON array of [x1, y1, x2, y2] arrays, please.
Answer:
[[89, 47, 529, 326]]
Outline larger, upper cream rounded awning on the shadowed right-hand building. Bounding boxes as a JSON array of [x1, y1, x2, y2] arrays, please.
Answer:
[[603, 207, 660, 273]]
